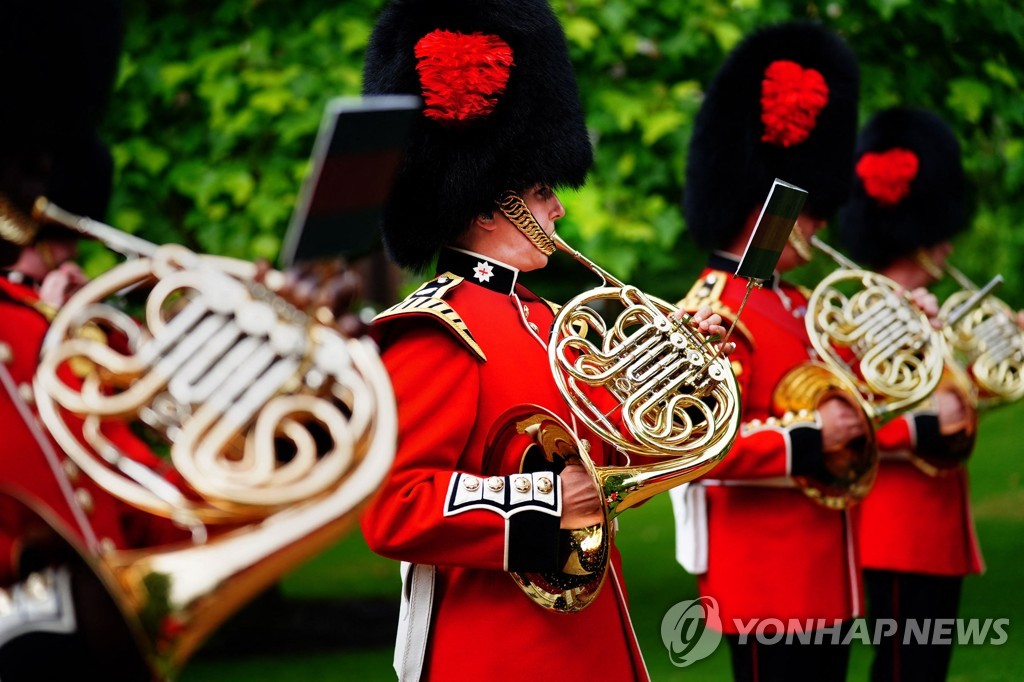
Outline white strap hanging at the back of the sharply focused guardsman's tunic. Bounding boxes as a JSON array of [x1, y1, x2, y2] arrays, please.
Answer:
[[394, 561, 435, 682]]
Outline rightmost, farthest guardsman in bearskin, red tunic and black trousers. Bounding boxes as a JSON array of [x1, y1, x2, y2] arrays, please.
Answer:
[[840, 108, 983, 681]]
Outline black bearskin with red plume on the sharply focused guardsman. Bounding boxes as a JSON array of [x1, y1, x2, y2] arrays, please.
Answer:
[[362, 0, 593, 268]]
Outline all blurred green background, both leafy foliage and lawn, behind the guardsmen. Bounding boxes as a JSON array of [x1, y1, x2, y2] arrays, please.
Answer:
[[92, 0, 1024, 682]]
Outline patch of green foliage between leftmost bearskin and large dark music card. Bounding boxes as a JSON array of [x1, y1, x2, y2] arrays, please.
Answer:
[[108, 0, 379, 266]]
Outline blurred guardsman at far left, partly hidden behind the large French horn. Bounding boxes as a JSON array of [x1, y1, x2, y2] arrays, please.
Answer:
[[0, 0, 192, 682]]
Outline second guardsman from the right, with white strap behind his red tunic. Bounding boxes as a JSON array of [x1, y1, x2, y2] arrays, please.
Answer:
[[672, 23, 869, 680]]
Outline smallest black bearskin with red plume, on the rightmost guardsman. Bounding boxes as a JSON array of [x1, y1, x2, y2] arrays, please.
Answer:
[[840, 108, 968, 267]]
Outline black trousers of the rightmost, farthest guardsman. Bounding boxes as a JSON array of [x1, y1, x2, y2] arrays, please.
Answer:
[[864, 570, 964, 682]]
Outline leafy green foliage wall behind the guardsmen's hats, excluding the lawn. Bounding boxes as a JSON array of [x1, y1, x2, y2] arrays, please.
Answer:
[[101, 0, 1024, 306]]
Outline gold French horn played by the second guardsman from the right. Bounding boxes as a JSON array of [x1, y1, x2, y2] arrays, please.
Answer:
[[772, 230, 945, 509]]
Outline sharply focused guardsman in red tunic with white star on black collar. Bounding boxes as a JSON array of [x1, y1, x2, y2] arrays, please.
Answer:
[[361, 0, 724, 680]]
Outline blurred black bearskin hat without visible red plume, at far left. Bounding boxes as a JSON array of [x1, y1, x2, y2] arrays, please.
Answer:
[[0, 0, 123, 263]]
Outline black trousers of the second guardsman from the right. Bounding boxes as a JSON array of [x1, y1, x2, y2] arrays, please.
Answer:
[[726, 621, 853, 682]]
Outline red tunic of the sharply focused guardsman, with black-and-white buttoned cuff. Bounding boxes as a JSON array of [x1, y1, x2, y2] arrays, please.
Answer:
[[361, 250, 646, 681]]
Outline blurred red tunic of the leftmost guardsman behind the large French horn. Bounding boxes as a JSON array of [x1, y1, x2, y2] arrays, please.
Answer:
[[0, 270, 185, 582]]
